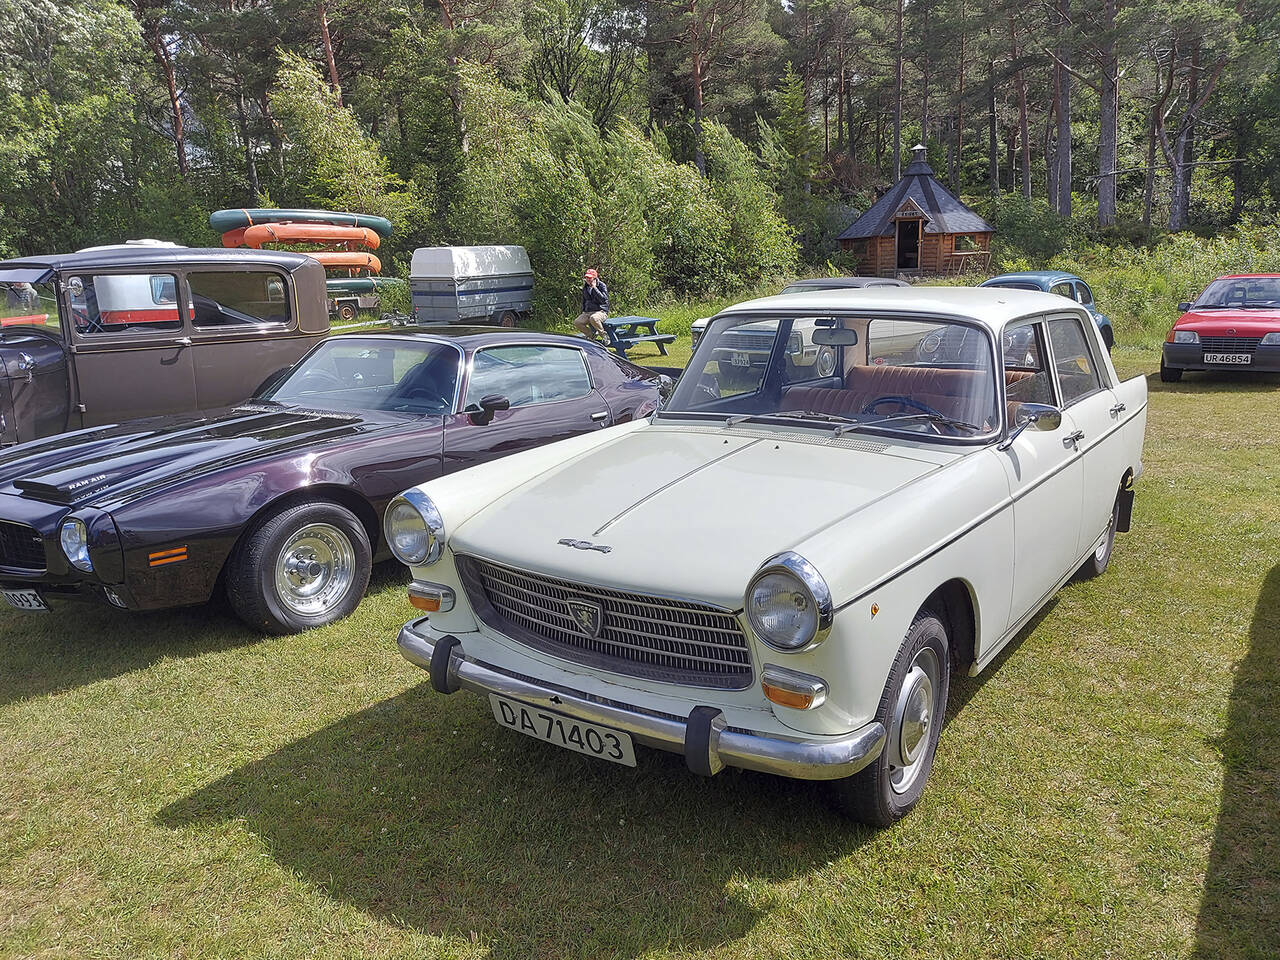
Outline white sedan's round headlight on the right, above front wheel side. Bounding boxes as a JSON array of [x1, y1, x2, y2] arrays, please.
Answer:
[[746, 553, 833, 653]]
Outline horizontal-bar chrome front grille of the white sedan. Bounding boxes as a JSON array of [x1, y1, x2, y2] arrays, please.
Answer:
[[458, 557, 753, 690]]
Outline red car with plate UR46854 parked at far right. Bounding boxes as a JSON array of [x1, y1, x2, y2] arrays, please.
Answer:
[[1160, 274, 1280, 383]]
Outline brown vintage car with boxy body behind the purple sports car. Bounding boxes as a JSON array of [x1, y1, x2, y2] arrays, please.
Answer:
[[0, 242, 329, 445]]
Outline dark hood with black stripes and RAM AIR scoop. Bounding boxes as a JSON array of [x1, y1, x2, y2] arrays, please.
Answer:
[[0, 404, 420, 506]]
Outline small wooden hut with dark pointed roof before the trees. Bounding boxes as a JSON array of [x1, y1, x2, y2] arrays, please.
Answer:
[[840, 145, 995, 276]]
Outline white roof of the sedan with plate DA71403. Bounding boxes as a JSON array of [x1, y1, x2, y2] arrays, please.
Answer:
[[721, 287, 1084, 332]]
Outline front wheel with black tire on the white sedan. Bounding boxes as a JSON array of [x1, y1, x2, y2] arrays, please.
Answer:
[[832, 608, 951, 827]]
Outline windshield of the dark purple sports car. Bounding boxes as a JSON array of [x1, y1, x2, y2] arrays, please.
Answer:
[[257, 337, 462, 415]]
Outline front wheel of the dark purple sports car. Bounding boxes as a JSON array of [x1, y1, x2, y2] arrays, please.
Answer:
[[227, 500, 372, 634]]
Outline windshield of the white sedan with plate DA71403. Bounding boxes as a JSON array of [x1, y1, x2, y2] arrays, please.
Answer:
[[662, 316, 1000, 438]]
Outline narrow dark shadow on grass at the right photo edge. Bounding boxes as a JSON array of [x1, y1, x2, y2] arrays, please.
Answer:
[[1194, 564, 1280, 960]]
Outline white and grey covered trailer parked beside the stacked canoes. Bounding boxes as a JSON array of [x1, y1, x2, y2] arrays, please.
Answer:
[[408, 246, 534, 326]]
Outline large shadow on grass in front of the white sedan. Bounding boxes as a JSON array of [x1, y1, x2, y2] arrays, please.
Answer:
[[157, 684, 872, 960]]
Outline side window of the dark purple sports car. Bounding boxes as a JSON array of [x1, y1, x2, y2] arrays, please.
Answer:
[[465, 344, 591, 407]]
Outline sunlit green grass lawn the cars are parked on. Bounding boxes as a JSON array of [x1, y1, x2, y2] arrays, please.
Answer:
[[0, 353, 1280, 960]]
